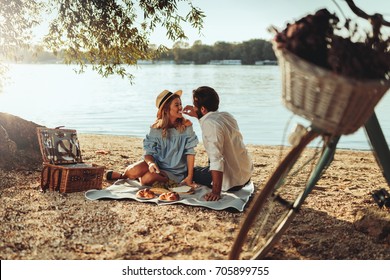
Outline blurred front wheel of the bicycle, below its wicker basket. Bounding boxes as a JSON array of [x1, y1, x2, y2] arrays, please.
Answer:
[[229, 130, 323, 259]]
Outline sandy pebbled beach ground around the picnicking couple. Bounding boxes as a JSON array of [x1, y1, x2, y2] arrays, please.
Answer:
[[0, 134, 390, 260]]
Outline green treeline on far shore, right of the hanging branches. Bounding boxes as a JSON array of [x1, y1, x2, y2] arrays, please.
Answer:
[[161, 39, 276, 65]]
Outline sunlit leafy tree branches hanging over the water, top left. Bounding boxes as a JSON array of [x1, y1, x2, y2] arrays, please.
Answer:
[[0, 0, 204, 79]]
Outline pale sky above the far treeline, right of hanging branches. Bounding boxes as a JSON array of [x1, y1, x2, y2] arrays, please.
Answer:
[[151, 0, 390, 47]]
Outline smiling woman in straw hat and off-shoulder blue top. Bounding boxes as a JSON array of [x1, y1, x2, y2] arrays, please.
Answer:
[[106, 90, 199, 186]]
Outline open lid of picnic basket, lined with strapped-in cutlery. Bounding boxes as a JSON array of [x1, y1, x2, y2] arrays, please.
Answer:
[[37, 127, 83, 164]]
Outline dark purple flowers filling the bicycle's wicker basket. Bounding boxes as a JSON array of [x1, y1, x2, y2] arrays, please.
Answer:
[[275, 9, 390, 79]]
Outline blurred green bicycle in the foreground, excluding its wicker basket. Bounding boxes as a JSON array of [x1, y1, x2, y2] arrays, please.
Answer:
[[229, 0, 390, 259]]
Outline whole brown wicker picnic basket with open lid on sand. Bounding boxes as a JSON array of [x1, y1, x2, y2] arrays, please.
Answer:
[[37, 127, 104, 193]]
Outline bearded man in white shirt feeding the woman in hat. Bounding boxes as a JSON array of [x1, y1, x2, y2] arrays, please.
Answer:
[[183, 86, 253, 201]]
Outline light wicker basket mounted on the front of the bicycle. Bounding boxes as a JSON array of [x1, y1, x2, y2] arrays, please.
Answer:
[[274, 43, 390, 135]]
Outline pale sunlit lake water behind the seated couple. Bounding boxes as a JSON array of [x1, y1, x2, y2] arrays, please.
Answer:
[[0, 64, 390, 149]]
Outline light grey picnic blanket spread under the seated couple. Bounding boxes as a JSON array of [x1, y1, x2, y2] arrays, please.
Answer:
[[85, 179, 254, 212]]
